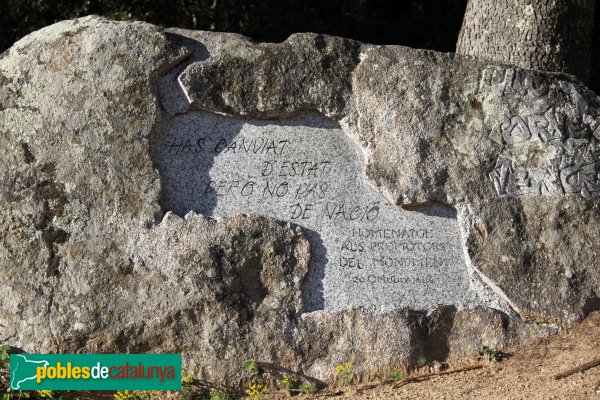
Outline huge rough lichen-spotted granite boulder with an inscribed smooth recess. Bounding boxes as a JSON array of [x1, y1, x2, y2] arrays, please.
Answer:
[[0, 17, 600, 383]]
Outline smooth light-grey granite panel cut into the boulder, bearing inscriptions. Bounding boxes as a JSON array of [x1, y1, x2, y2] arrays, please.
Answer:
[[155, 113, 475, 311]]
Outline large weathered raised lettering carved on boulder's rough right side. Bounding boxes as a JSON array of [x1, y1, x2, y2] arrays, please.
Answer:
[[477, 66, 600, 199]]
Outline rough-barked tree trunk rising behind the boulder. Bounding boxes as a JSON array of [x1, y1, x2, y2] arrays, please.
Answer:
[[456, 0, 595, 82]]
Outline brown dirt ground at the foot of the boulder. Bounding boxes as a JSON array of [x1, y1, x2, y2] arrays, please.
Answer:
[[270, 312, 600, 400]]
